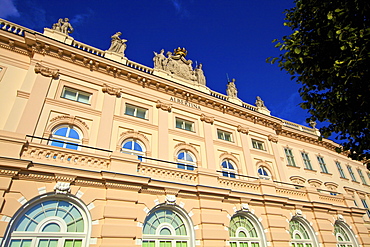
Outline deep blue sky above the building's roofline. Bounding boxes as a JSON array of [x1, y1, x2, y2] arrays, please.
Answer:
[[0, 0, 308, 125]]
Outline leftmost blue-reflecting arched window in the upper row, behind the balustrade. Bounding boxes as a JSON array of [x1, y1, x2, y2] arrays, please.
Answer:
[[49, 125, 82, 150]]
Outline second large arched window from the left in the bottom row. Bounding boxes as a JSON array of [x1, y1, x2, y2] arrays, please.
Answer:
[[142, 207, 194, 247]]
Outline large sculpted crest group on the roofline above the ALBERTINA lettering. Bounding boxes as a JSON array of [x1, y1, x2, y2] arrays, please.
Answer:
[[153, 47, 206, 86]]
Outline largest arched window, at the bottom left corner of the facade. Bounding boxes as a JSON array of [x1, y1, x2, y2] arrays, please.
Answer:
[[4, 194, 91, 247]]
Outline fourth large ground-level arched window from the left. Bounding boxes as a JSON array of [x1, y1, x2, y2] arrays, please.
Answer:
[[289, 218, 317, 247]]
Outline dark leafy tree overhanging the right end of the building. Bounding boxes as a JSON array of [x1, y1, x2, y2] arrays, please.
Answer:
[[268, 0, 370, 166]]
